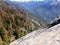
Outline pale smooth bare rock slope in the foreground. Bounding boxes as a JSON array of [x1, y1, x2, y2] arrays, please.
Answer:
[[9, 24, 60, 45]]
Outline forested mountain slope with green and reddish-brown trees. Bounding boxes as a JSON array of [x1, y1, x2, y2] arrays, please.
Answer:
[[0, 0, 43, 45]]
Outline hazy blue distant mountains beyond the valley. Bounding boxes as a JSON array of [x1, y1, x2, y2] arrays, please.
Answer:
[[6, 0, 60, 22]]
